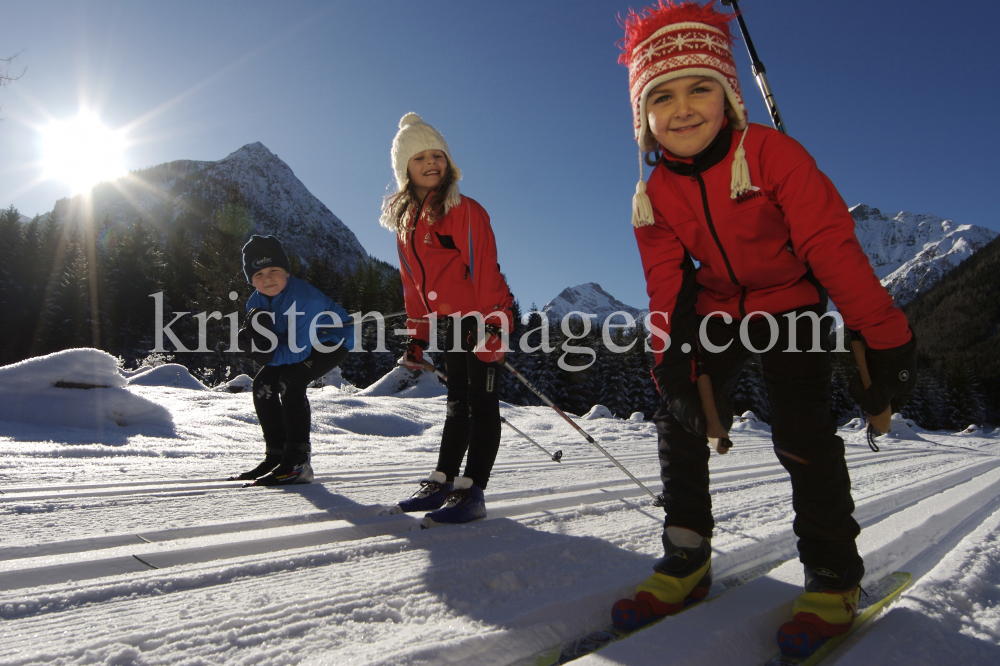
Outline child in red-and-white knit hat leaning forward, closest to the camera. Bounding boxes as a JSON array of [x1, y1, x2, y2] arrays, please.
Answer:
[[613, 0, 916, 649]]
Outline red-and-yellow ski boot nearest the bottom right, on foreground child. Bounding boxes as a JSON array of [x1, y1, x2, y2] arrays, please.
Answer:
[[778, 565, 865, 658]]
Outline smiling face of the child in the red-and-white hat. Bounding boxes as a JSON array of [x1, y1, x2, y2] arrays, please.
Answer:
[[646, 76, 726, 157]]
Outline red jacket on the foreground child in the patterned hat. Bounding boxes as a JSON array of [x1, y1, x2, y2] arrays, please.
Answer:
[[635, 124, 911, 363]]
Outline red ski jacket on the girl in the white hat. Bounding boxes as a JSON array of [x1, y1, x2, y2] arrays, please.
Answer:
[[396, 194, 514, 322]]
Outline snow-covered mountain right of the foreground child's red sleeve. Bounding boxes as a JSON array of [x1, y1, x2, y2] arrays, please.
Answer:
[[851, 204, 997, 305]]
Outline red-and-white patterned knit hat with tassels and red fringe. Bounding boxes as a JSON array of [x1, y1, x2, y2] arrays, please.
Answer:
[[618, 0, 750, 226]]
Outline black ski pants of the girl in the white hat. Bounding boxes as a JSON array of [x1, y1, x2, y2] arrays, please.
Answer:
[[436, 317, 501, 489]]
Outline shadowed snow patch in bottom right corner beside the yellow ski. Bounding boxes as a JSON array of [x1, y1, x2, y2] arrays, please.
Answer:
[[850, 607, 1000, 666]]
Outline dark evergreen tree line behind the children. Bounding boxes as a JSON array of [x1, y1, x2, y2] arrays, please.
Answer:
[[0, 197, 996, 430]]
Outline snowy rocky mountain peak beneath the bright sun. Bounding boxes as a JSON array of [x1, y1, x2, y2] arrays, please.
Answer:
[[49, 142, 367, 270]]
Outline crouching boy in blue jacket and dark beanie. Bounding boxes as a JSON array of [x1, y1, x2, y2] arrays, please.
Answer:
[[230, 236, 354, 486]]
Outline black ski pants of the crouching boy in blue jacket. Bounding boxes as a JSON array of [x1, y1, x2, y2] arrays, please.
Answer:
[[253, 345, 350, 450]]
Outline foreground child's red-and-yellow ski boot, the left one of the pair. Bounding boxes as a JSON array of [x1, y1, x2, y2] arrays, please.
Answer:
[[611, 525, 712, 632]]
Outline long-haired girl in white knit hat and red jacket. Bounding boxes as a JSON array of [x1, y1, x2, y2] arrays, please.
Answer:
[[380, 113, 514, 524]]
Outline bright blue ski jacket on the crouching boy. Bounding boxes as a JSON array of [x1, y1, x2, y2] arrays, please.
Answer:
[[247, 275, 354, 365]]
